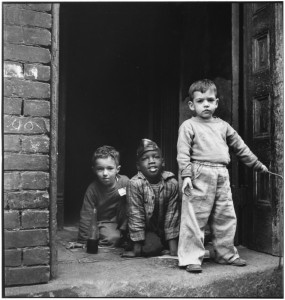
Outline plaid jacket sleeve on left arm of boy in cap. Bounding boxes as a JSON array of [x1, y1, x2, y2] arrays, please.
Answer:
[[127, 180, 145, 242]]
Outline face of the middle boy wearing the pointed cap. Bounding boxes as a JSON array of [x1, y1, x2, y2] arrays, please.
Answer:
[[137, 150, 164, 183]]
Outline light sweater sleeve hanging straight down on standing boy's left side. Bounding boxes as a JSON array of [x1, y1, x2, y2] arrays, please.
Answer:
[[177, 122, 193, 178]]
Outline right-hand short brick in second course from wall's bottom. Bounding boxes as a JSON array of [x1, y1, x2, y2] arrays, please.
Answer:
[[23, 248, 50, 266]]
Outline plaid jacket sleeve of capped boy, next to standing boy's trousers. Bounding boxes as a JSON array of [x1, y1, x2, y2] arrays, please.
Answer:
[[164, 179, 179, 241]]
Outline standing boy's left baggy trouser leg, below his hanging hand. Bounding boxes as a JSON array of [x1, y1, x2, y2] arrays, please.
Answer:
[[178, 166, 217, 266]]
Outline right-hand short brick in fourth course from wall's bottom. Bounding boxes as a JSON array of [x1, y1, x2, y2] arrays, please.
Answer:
[[21, 210, 49, 229]]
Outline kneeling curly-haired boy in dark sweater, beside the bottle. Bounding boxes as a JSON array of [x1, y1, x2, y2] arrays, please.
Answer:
[[78, 146, 129, 246]]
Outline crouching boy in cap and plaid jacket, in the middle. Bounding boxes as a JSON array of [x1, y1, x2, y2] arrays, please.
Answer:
[[124, 139, 179, 257]]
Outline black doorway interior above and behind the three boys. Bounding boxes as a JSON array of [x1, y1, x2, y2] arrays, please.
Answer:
[[58, 2, 231, 227]]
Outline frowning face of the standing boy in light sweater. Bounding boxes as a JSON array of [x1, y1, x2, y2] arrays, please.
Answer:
[[188, 88, 219, 119]]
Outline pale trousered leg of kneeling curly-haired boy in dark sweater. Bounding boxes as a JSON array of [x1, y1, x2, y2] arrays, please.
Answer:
[[98, 222, 121, 247]]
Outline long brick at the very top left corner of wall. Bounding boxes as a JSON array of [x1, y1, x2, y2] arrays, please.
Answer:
[[4, 7, 51, 28]]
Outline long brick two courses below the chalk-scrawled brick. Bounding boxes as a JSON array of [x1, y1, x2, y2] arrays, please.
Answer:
[[4, 153, 49, 171]]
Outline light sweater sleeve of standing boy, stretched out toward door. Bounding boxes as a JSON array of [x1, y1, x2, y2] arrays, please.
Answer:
[[227, 124, 263, 171]]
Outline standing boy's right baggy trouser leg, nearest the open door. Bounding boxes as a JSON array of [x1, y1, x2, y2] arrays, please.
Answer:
[[209, 168, 239, 263]]
